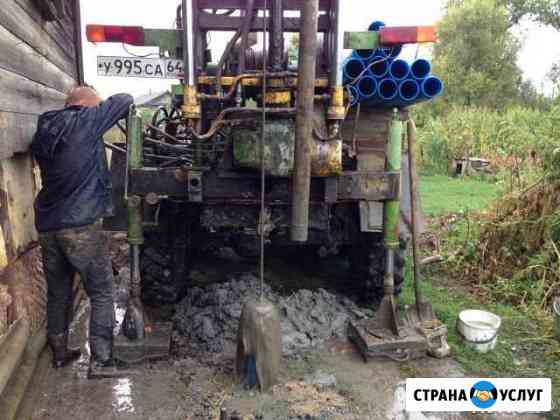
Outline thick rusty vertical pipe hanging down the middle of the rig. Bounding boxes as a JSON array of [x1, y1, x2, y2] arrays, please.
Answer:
[[291, 0, 319, 242]]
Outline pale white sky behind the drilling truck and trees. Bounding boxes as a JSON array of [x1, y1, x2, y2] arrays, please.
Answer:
[[81, 0, 560, 96]]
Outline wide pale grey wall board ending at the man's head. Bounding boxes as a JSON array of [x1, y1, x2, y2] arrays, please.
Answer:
[[0, 69, 66, 114]]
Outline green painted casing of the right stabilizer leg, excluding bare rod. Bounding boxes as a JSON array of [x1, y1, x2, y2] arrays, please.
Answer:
[[383, 109, 403, 248]]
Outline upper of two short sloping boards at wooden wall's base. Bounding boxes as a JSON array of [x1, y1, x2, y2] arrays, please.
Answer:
[[0, 319, 29, 395]]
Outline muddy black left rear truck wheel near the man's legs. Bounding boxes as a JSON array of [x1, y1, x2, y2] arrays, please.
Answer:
[[140, 233, 187, 306]]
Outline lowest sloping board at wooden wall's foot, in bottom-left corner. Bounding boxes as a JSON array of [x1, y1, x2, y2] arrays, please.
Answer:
[[0, 327, 47, 420]]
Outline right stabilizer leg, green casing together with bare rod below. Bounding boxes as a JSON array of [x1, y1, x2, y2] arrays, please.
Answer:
[[383, 109, 402, 296]]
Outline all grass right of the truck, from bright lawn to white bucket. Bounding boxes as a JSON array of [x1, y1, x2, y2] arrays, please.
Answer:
[[406, 176, 560, 418]]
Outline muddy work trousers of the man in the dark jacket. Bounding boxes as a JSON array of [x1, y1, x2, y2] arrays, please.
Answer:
[[39, 223, 115, 350]]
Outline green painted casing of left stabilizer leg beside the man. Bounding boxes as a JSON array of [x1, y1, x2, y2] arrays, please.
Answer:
[[127, 106, 144, 245]]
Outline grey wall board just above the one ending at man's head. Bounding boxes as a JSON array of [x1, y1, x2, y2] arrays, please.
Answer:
[[0, 26, 76, 93]]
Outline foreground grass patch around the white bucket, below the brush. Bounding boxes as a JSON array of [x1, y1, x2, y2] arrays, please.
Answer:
[[399, 270, 560, 418]]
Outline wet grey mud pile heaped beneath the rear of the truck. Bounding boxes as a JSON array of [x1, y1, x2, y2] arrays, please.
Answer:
[[174, 274, 362, 356]]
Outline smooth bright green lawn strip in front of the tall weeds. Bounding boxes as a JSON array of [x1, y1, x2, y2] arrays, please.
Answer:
[[419, 175, 500, 217]]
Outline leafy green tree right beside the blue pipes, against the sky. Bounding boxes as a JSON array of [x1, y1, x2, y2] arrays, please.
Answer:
[[434, 0, 522, 109]]
